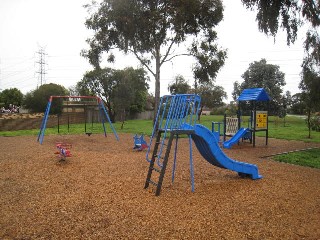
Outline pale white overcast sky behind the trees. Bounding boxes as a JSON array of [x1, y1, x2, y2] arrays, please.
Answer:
[[0, 0, 304, 102]]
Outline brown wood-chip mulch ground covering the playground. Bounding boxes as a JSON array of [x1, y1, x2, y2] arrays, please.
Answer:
[[0, 134, 320, 239]]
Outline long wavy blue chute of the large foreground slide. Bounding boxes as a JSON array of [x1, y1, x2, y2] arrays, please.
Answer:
[[192, 124, 262, 179]]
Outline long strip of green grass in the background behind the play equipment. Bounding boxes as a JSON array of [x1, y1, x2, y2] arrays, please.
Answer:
[[0, 115, 320, 143]]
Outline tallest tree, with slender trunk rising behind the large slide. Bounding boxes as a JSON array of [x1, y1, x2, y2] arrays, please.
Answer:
[[82, 0, 226, 120]]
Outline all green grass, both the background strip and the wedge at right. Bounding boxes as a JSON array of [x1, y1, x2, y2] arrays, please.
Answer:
[[0, 115, 320, 168]]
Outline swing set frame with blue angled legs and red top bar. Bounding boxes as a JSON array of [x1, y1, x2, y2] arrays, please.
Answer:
[[37, 96, 119, 144]]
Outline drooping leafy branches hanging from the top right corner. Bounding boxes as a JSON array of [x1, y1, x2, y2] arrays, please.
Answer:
[[242, 0, 320, 71]]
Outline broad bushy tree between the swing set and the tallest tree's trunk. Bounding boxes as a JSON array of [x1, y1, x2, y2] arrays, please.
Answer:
[[77, 68, 149, 121]]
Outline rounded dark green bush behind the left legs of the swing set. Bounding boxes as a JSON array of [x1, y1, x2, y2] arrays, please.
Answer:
[[23, 83, 69, 114]]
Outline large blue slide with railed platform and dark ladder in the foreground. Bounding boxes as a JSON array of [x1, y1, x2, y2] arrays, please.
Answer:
[[144, 94, 262, 196]]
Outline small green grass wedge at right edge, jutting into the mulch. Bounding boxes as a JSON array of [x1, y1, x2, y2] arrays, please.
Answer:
[[273, 148, 320, 169]]
